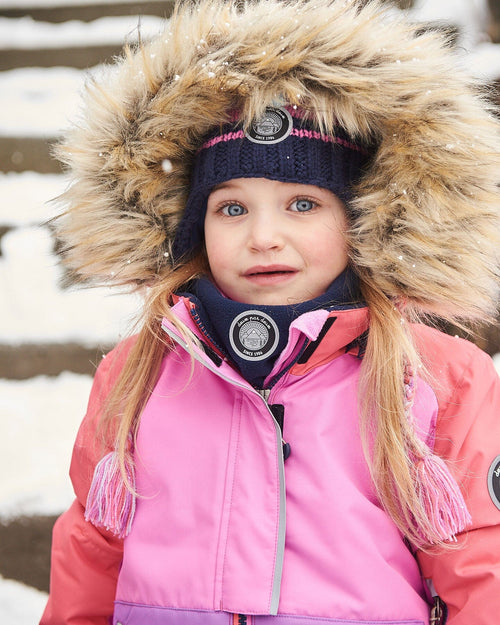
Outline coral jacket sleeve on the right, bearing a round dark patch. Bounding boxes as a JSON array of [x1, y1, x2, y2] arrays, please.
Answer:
[[417, 337, 500, 625]]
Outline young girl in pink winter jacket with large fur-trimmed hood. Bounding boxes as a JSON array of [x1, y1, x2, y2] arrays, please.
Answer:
[[42, 0, 500, 625]]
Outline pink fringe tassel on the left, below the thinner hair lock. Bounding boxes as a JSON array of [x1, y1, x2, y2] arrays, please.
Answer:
[[85, 451, 136, 538]]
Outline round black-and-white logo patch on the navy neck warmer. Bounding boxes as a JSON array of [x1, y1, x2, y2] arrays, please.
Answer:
[[229, 310, 279, 361]]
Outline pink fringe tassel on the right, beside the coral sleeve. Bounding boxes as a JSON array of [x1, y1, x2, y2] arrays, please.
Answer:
[[417, 453, 472, 540]]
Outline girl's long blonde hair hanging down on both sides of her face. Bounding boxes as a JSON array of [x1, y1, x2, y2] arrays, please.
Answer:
[[101, 246, 468, 549]]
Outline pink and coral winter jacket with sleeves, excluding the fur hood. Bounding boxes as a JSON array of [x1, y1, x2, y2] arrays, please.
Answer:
[[41, 300, 500, 625]]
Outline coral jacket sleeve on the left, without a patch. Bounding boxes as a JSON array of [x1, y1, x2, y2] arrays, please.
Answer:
[[40, 345, 133, 625]]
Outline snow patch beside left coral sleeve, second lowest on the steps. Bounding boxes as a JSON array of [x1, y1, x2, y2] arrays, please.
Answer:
[[0, 372, 92, 520]]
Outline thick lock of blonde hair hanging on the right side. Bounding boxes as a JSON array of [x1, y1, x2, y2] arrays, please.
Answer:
[[359, 281, 453, 549]]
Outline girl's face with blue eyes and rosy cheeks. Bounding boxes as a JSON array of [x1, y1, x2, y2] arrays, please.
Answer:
[[205, 178, 347, 305]]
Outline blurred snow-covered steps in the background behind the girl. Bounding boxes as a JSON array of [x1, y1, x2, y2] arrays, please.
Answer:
[[0, 0, 500, 625]]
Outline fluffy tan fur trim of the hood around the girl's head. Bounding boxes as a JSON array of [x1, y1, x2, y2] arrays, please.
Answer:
[[56, 0, 500, 318]]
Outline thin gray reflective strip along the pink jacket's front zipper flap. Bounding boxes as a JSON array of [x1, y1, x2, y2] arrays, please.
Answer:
[[162, 325, 286, 615]]
